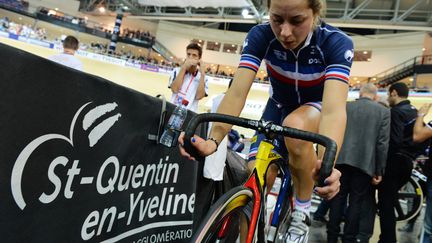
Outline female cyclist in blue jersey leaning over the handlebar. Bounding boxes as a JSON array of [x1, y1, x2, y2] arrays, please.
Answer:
[[179, 0, 354, 242]]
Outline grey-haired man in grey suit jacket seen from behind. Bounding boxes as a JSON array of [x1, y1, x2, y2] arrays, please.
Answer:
[[327, 83, 390, 243]]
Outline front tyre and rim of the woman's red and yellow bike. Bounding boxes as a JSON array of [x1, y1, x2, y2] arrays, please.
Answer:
[[191, 186, 253, 243]]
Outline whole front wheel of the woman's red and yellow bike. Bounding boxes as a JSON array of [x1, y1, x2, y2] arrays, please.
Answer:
[[191, 186, 253, 243]]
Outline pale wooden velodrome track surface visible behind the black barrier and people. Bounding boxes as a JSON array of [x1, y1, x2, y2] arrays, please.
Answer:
[[0, 37, 432, 136]]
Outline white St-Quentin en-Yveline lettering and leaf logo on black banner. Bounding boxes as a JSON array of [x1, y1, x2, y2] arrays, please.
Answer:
[[11, 102, 195, 242]]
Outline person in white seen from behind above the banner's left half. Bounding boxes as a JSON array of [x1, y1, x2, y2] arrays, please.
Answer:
[[48, 35, 83, 71]]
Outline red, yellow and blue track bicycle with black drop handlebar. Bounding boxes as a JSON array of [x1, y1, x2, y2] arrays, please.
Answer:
[[184, 113, 337, 242]]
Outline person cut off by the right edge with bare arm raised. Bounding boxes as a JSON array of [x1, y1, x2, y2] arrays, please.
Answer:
[[413, 103, 432, 243]]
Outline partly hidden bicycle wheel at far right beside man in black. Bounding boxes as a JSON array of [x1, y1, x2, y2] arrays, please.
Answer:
[[394, 177, 423, 221]]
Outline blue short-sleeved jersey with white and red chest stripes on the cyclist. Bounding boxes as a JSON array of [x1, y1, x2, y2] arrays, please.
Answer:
[[239, 22, 354, 106]]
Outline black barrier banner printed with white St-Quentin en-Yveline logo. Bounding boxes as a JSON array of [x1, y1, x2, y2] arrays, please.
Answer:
[[0, 44, 207, 243]]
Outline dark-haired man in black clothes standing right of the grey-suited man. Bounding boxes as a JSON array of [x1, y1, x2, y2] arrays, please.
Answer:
[[378, 83, 417, 243]]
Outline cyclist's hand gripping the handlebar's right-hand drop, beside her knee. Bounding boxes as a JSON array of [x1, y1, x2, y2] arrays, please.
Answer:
[[313, 160, 342, 200]]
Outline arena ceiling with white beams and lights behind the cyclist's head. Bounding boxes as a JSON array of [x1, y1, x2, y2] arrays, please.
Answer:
[[81, 0, 432, 32]]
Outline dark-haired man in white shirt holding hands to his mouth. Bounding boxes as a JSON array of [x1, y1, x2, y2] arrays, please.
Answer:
[[170, 43, 208, 112]]
